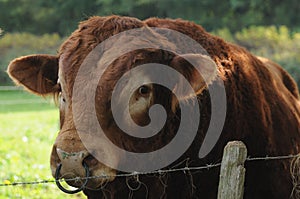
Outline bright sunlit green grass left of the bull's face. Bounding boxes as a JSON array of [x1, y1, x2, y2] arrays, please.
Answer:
[[0, 90, 85, 199]]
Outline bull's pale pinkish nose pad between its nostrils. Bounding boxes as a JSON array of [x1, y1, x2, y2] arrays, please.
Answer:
[[56, 148, 89, 178]]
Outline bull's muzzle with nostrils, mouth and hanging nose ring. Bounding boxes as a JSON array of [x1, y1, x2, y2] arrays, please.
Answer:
[[51, 147, 116, 194]]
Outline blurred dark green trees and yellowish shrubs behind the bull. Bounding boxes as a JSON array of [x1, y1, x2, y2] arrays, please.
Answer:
[[0, 0, 300, 85]]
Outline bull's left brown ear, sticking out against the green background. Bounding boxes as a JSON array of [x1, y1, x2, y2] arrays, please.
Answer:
[[7, 55, 59, 95]]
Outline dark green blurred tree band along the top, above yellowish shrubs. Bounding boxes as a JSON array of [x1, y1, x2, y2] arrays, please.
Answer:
[[0, 0, 300, 35]]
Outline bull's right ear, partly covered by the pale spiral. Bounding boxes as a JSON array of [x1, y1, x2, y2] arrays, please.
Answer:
[[170, 54, 218, 110]]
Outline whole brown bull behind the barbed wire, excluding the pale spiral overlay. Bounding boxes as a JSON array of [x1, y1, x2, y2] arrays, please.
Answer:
[[8, 16, 300, 199]]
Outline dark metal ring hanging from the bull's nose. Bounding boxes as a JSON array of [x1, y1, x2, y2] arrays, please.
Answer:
[[55, 162, 90, 194]]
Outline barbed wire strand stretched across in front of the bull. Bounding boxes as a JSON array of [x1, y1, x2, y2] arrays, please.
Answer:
[[0, 154, 300, 187]]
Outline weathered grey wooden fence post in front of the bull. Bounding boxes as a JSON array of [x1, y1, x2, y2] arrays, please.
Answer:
[[218, 141, 247, 199]]
